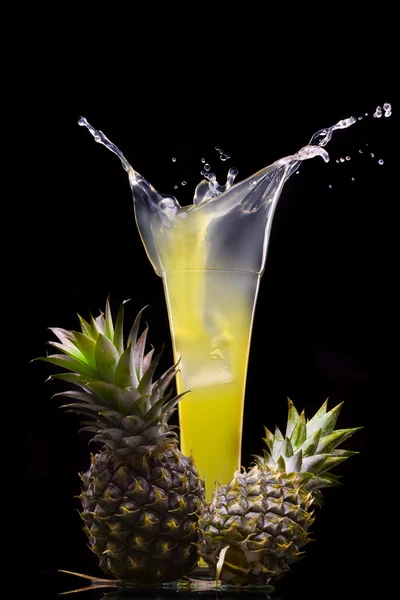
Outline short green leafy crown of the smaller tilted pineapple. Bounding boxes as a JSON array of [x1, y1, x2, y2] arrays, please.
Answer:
[[256, 399, 361, 490]]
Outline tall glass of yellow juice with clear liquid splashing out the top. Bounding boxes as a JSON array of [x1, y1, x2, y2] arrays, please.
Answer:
[[79, 117, 356, 499]]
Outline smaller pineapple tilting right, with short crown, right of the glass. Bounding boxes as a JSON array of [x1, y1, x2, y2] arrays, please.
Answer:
[[198, 400, 359, 584]]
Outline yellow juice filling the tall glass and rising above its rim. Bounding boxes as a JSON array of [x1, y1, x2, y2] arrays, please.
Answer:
[[157, 210, 259, 498]]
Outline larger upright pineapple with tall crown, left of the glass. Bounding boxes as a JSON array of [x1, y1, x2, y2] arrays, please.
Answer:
[[43, 300, 204, 582]]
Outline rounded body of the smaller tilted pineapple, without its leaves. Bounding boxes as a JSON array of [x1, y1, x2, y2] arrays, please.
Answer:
[[198, 465, 314, 585]]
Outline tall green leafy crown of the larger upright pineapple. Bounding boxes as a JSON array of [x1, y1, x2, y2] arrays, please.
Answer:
[[39, 298, 183, 455]]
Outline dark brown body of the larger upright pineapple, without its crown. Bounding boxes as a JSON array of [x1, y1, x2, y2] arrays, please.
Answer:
[[80, 444, 204, 583]]
